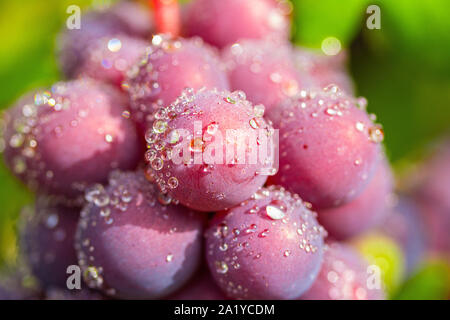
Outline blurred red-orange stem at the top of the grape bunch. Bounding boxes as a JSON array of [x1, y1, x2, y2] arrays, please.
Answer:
[[149, 0, 181, 37]]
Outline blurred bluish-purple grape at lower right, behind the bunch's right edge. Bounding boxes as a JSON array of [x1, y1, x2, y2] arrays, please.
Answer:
[[380, 196, 427, 274]]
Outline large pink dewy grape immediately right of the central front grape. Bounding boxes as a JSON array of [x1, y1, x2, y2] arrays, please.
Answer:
[[266, 86, 383, 210]]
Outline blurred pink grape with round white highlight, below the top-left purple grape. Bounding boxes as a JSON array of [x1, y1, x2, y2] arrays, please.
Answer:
[[76, 35, 147, 87]]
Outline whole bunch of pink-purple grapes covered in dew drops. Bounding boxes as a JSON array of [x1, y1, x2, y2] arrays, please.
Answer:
[[0, 0, 450, 299]]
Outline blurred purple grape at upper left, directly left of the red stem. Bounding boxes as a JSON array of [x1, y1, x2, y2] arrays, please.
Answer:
[[57, 1, 153, 78]]
